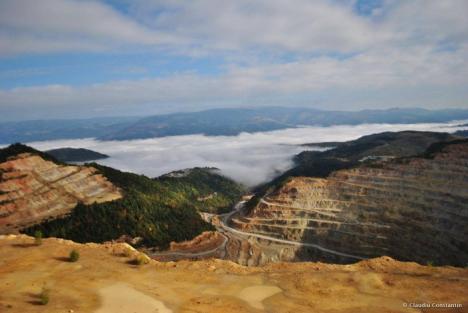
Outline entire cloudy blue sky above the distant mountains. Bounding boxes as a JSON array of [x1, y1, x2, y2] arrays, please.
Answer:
[[0, 0, 468, 120]]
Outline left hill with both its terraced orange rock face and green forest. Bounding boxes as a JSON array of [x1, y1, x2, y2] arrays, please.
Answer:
[[0, 144, 242, 248]]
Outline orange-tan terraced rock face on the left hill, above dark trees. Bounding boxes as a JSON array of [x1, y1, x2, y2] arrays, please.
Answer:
[[0, 153, 122, 233]]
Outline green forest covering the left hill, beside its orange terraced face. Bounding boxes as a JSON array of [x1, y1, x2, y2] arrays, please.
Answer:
[[24, 163, 242, 248]]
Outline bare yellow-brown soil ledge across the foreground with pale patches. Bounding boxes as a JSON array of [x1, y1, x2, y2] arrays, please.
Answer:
[[0, 235, 468, 313]]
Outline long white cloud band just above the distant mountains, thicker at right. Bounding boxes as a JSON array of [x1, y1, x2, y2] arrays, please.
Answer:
[[0, 41, 468, 119]]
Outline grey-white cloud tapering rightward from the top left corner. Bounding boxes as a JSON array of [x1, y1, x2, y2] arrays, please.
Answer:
[[0, 0, 176, 54]]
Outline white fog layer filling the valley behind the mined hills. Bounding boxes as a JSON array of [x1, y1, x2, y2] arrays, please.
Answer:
[[26, 123, 466, 186]]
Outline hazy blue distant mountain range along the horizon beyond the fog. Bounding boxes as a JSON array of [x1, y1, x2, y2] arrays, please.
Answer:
[[0, 107, 468, 144]]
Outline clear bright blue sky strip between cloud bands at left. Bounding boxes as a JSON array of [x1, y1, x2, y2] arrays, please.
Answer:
[[0, 51, 227, 88]]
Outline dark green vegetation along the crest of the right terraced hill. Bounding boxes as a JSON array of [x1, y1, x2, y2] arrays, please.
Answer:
[[246, 131, 457, 210]]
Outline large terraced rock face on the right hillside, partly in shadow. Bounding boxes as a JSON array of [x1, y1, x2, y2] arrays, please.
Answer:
[[238, 142, 468, 266]]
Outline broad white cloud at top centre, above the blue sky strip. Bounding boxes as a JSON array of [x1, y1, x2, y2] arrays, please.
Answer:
[[143, 0, 377, 52]]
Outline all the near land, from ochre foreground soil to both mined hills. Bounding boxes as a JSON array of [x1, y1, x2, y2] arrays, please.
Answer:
[[0, 132, 468, 313]]
